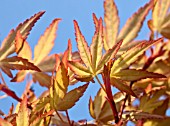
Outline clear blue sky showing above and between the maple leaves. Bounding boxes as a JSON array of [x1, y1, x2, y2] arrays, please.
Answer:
[[0, 0, 149, 123]]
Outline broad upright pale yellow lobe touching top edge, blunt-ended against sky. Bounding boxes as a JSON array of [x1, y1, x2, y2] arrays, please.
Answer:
[[104, 0, 120, 50]]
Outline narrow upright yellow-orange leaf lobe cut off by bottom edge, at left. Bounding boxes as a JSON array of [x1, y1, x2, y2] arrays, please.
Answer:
[[16, 96, 29, 126]]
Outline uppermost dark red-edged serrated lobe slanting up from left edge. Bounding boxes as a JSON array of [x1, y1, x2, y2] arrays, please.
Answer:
[[0, 11, 45, 60]]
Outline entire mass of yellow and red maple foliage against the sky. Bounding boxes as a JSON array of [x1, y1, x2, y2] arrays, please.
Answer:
[[0, 0, 170, 126]]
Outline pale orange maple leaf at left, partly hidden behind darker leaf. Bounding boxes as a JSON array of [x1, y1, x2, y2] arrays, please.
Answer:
[[11, 19, 60, 87]]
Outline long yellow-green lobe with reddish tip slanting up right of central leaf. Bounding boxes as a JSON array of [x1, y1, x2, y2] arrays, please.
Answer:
[[111, 38, 163, 75]]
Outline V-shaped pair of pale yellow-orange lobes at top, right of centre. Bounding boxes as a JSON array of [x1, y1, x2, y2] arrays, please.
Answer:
[[104, 0, 154, 50]]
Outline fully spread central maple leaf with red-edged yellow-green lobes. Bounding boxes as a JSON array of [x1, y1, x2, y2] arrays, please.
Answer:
[[68, 17, 122, 81]]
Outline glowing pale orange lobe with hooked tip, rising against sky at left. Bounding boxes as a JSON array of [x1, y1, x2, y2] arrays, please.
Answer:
[[34, 19, 60, 64]]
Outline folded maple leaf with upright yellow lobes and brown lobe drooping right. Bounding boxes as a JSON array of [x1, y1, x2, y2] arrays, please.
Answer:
[[50, 55, 88, 111]]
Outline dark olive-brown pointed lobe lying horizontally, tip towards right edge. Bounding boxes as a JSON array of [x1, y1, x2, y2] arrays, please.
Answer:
[[110, 69, 166, 81]]
